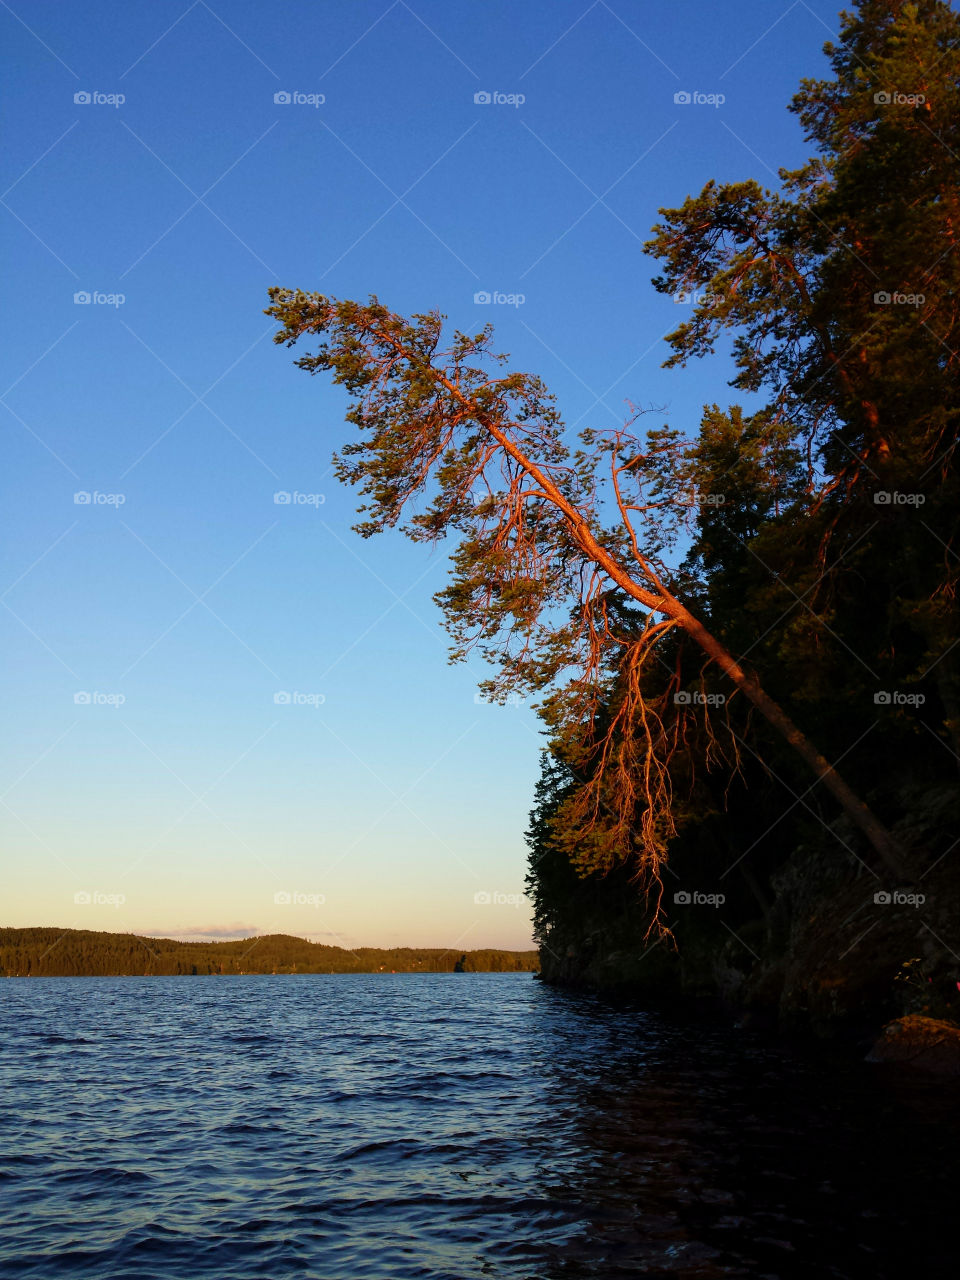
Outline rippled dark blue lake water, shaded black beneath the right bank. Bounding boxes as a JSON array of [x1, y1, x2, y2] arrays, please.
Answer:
[[0, 974, 959, 1280]]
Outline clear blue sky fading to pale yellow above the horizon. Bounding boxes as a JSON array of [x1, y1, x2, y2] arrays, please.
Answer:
[[0, 0, 837, 948]]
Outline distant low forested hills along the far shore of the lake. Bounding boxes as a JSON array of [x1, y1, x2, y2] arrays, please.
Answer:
[[0, 929, 540, 978]]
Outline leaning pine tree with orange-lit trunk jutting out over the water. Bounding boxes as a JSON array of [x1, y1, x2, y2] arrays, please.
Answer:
[[268, 288, 902, 881]]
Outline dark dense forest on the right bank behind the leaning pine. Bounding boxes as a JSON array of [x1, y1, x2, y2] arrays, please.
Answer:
[[529, 0, 960, 1029]]
